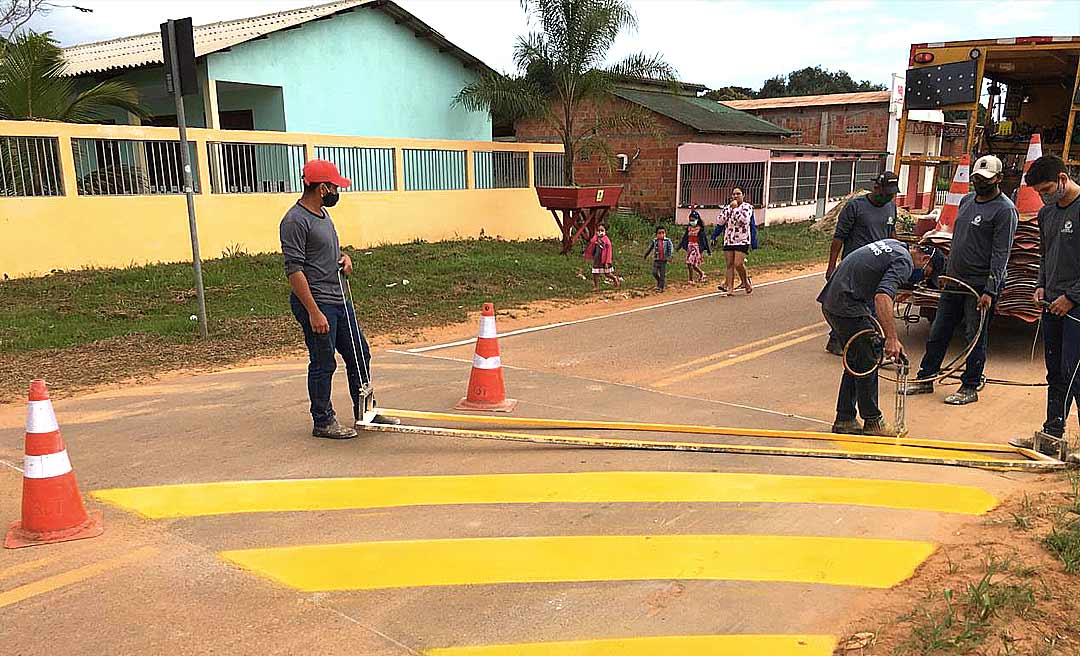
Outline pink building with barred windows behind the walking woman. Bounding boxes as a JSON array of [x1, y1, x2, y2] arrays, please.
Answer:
[[675, 144, 888, 226]]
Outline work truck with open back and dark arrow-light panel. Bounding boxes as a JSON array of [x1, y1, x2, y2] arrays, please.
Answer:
[[894, 37, 1080, 322]]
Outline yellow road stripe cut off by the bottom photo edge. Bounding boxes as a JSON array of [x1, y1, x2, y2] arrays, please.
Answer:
[[424, 635, 836, 656]]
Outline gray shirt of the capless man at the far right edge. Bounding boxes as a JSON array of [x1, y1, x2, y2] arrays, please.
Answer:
[[1039, 193, 1080, 305]]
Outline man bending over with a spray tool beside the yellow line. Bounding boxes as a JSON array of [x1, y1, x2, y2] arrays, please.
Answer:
[[818, 239, 933, 437]]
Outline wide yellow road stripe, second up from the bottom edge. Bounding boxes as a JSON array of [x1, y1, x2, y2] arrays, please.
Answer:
[[220, 535, 934, 592]]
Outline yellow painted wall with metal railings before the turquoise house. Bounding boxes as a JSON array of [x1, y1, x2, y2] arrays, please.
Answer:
[[0, 121, 562, 277]]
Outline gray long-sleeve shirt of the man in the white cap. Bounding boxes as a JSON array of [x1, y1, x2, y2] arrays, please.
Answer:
[[946, 193, 1020, 296]]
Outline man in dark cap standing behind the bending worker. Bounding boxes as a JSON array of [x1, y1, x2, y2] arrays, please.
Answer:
[[825, 171, 900, 356]]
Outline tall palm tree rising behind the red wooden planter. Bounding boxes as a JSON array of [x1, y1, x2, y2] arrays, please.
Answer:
[[455, 0, 675, 185]]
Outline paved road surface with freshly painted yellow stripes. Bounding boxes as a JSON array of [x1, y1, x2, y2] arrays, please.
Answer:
[[0, 269, 1043, 656]]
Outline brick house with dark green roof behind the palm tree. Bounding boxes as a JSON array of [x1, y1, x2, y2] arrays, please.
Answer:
[[514, 80, 788, 218]]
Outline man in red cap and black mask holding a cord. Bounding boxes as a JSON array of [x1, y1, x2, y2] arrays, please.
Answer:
[[279, 160, 392, 440]]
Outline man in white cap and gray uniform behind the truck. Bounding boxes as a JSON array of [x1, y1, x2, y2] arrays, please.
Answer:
[[907, 155, 1018, 405]]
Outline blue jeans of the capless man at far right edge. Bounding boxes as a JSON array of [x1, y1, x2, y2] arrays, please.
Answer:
[[1042, 308, 1080, 438]]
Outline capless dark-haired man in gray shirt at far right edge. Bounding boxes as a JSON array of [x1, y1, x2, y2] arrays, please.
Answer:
[[1011, 155, 1080, 463]]
